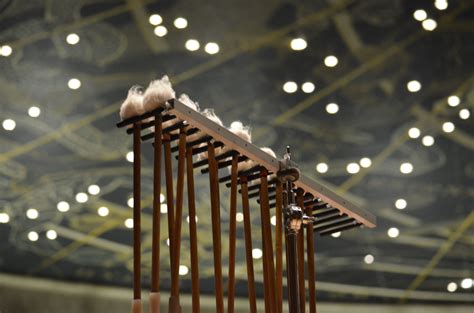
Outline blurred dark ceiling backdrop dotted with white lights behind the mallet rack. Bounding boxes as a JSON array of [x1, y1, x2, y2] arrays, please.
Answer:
[[0, 0, 474, 313]]
